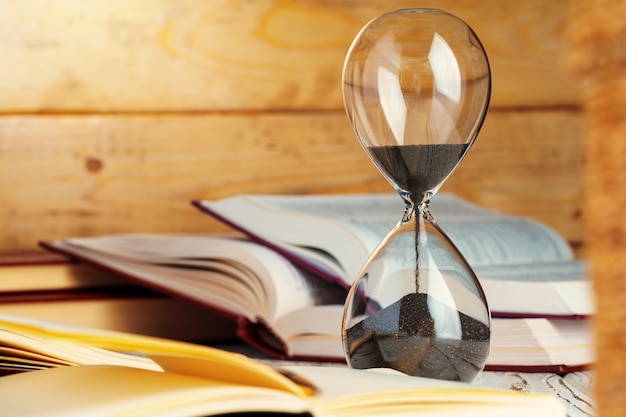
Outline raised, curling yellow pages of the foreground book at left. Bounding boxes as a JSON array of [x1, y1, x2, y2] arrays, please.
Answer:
[[0, 315, 302, 395]]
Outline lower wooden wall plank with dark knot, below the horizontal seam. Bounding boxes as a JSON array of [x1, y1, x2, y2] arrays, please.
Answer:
[[0, 111, 582, 250]]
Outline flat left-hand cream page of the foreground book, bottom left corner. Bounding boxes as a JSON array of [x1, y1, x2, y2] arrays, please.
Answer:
[[0, 365, 307, 417]]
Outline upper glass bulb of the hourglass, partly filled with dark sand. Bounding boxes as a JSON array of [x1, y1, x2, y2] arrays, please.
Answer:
[[343, 9, 491, 204]]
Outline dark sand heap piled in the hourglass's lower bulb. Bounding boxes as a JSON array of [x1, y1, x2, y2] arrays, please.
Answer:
[[346, 293, 489, 381]]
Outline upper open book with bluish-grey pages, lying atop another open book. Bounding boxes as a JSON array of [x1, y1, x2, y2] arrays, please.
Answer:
[[193, 193, 594, 317]]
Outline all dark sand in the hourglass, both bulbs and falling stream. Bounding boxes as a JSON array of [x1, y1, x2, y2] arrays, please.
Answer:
[[346, 144, 490, 381]]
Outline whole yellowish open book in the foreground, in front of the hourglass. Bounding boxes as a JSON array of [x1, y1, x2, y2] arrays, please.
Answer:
[[0, 316, 566, 417]]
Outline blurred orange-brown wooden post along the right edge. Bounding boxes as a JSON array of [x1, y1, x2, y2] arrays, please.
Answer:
[[568, 0, 626, 417]]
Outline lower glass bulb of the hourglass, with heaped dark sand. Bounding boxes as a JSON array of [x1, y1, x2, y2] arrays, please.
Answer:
[[343, 197, 490, 381]]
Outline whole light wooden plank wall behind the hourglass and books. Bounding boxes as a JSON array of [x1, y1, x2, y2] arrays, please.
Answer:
[[0, 0, 584, 253]]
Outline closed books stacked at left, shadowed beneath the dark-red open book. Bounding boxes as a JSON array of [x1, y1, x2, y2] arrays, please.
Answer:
[[0, 247, 236, 342]]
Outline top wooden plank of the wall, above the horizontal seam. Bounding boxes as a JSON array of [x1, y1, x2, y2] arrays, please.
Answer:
[[0, 0, 579, 114]]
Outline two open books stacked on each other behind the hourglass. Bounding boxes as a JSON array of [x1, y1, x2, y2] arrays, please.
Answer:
[[42, 194, 594, 373]]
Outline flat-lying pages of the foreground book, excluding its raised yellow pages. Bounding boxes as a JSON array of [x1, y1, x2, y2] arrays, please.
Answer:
[[0, 365, 566, 417]]
